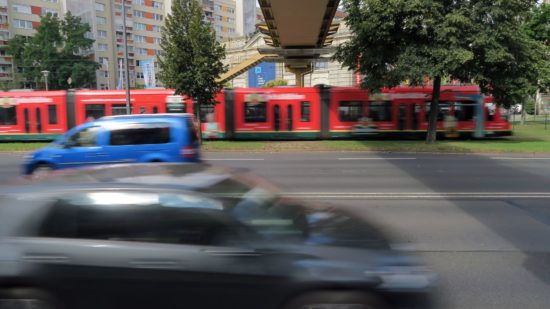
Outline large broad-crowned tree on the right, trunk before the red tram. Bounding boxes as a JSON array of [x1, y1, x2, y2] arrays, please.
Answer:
[[335, 0, 543, 143]]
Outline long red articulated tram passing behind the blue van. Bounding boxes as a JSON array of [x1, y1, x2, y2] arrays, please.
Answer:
[[0, 86, 511, 140]]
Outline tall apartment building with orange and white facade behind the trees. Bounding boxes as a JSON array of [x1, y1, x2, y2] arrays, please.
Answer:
[[0, 0, 250, 89]]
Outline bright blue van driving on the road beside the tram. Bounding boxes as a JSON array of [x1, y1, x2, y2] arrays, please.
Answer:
[[23, 114, 200, 175]]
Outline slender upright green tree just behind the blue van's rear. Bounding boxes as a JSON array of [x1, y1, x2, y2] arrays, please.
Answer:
[[158, 0, 227, 137]]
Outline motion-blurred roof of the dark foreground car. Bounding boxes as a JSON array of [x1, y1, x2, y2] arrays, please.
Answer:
[[0, 163, 278, 195]]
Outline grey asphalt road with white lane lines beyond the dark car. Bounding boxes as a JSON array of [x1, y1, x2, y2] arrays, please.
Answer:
[[0, 152, 550, 308]]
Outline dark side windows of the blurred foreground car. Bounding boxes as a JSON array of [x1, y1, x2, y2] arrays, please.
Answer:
[[36, 191, 248, 245]]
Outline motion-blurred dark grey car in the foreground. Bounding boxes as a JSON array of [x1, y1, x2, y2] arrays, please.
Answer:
[[0, 164, 440, 309]]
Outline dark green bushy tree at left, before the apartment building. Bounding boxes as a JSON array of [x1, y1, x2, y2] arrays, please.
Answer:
[[6, 12, 100, 90]]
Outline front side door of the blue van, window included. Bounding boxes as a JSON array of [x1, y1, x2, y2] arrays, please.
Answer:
[[55, 126, 110, 168]]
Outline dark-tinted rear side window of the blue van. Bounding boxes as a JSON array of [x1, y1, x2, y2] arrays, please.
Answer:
[[109, 123, 170, 146]]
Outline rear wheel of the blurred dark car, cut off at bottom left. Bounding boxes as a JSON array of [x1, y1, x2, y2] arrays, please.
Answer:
[[0, 289, 61, 309]]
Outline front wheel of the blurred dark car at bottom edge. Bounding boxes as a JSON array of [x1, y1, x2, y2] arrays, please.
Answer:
[[282, 291, 385, 309]]
